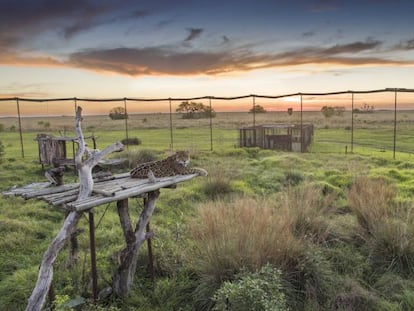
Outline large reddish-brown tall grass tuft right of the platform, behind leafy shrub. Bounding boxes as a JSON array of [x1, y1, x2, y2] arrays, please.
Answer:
[[190, 198, 302, 283]]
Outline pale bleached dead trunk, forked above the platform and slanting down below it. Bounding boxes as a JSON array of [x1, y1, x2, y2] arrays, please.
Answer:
[[26, 107, 123, 311]]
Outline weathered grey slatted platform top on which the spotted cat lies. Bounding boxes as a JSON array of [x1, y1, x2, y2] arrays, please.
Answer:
[[3, 173, 198, 211]]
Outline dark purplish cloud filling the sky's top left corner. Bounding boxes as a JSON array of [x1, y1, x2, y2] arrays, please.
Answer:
[[0, 0, 142, 49]]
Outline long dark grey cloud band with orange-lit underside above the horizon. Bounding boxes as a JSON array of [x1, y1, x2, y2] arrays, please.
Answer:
[[67, 40, 413, 76]]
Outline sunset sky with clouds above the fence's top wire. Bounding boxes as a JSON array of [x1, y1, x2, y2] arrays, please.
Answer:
[[0, 0, 414, 109]]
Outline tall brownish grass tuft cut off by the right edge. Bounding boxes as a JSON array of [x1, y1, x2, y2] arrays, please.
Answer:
[[348, 177, 414, 274]]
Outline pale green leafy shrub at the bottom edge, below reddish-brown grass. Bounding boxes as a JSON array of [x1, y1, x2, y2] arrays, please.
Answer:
[[214, 264, 288, 311]]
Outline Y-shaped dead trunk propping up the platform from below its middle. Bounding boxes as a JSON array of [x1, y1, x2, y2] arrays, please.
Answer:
[[112, 190, 159, 297]]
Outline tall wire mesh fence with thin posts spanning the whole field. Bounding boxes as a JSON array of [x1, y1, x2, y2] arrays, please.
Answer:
[[0, 89, 414, 158]]
